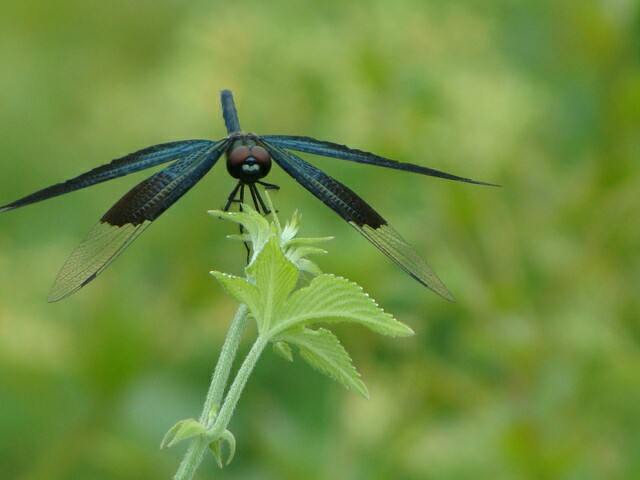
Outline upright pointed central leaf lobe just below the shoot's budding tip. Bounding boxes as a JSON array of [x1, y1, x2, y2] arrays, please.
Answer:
[[247, 234, 298, 333]]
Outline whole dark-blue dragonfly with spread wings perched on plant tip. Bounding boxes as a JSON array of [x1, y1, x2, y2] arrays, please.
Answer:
[[0, 90, 497, 302]]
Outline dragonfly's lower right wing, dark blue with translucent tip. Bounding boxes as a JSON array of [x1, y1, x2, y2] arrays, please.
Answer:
[[261, 141, 455, 301]]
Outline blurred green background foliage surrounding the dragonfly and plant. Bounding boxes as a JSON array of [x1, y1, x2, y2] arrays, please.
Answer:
[[0, 0, 640, 480]]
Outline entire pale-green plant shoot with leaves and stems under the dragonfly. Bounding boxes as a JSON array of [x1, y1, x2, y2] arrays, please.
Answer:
[[162, 197, 413, 480]]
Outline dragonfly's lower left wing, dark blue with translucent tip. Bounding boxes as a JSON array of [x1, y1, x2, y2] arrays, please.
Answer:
[[48, 140, 227, 302]]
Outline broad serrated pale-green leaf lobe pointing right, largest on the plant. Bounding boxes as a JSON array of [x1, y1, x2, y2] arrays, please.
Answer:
[[272, 275, 413, 336]]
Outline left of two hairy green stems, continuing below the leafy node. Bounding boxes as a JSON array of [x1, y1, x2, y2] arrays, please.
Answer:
[[173, 305, 248, 480]]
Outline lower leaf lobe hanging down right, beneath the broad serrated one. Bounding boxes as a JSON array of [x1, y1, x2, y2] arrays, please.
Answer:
[[278, 328, 369, 398]]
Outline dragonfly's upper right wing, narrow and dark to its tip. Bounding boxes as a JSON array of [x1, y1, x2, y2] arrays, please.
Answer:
[[260, 135, 498, 187]]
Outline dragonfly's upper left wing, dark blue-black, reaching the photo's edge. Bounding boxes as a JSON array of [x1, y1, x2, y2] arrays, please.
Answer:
[[0, 140, 214, 213]]
